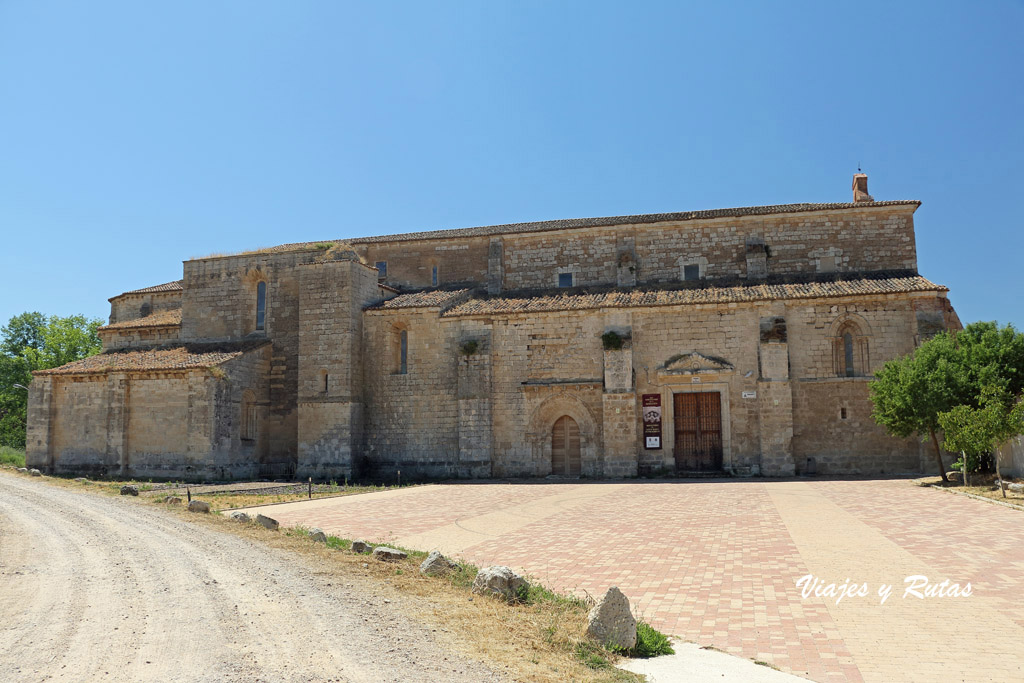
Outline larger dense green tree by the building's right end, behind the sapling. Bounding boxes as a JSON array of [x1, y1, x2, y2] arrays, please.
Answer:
[[871, 323, 1024, 479]]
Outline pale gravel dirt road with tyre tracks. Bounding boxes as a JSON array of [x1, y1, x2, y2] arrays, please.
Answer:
[[0, 473, 499, 682]]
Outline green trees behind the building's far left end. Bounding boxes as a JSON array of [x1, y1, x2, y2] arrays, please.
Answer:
[[0, 312, 102, 449]]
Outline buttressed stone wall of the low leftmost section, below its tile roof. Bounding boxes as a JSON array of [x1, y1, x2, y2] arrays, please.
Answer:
[[27, 345, 271, 479]]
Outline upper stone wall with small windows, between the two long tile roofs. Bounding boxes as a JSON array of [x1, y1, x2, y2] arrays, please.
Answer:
[[353, 205, 918, 292]]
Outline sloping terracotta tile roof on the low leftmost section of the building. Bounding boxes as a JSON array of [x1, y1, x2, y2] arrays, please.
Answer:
[[33, 339, 270, 376]]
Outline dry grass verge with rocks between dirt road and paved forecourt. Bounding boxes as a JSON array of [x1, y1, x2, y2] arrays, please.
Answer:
[[2, 466, 644, 683]]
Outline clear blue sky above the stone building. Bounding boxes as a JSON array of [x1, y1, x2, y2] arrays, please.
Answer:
[[0, 0, 1024, 328]]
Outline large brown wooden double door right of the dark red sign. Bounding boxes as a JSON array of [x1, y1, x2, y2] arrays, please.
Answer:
[[673, 391, 722, 472]]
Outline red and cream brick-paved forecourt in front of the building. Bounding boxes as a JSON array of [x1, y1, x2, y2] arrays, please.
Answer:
[[239, 479, 1024, 682]]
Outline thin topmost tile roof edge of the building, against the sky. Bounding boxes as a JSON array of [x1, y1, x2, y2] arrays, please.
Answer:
[[258, 200, 921, 252]]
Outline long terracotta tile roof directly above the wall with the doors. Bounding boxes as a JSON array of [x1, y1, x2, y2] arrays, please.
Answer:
[[443, 275, 948, 317]]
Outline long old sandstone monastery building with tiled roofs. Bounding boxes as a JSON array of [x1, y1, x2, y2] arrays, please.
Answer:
[[28, 174, 959, 479]]
